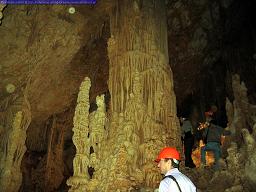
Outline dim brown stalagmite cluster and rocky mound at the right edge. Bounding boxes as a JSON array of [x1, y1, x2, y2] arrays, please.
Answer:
[[184, 75, 256, 192]]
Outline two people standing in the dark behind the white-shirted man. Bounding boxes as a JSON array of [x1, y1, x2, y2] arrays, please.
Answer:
[[181, 105, 231, 170]]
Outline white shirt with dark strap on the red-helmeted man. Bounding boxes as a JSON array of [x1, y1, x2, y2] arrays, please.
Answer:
[[159, 168, 196, 192]]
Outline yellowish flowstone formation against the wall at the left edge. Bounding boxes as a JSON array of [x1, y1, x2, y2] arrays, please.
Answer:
[[0, 96, 31, 191]]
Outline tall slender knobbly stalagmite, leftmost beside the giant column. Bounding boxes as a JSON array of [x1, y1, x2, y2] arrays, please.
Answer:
[[67, 77, 91, 192]]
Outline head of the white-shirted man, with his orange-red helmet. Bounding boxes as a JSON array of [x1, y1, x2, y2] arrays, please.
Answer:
[[155, 147, 180, 175]]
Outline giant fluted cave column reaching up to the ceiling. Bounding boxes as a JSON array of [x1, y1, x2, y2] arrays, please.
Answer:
[[87, 0, 180, 191]]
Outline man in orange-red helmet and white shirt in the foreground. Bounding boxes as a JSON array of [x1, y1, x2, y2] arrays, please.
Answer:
[[155, 147, 196, 192]]
